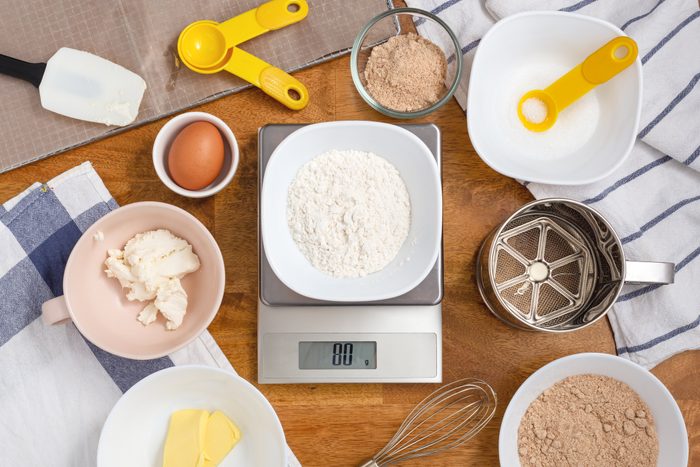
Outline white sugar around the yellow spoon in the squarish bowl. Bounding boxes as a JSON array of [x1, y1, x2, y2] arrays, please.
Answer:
[[504, 63, 600, 160]]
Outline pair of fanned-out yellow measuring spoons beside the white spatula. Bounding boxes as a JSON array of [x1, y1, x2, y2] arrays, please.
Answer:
[[177, 0, 309, 110]]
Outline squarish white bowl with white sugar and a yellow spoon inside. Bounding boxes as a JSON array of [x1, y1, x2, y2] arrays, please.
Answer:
[[467, 12, 642, 185]]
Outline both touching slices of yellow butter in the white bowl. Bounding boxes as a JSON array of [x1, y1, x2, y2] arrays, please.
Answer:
[[163, 409, 241, 467]]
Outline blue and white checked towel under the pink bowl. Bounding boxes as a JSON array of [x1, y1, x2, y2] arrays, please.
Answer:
[[0, 162, 300, 467]]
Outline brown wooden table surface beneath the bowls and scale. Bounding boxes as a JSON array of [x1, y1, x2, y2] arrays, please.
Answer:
[[0, 57, 700, 467]]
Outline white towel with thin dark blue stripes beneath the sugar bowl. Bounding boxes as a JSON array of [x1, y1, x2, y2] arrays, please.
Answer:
[[407, 0, 700, 368]]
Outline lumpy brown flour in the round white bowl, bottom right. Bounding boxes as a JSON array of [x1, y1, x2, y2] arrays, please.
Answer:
[[518, 375, 659, 467]]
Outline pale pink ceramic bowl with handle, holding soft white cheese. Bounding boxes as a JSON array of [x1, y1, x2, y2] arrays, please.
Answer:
[[42, 201, 225, 360]]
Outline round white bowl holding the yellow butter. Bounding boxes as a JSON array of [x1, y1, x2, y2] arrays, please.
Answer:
[[97, 365, 286, 467]]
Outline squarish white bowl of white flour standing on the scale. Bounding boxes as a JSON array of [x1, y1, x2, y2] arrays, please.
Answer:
[[260, 122, 442, 302]]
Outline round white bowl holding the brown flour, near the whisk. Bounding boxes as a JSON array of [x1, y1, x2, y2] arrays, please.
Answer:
[[498, 353, 688, 467]]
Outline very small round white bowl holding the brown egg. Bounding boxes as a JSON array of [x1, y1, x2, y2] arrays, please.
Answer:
[[153, 112, 239, 198]]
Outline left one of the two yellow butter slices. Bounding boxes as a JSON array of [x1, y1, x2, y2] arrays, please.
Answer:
[[163, 409, 209, 467]]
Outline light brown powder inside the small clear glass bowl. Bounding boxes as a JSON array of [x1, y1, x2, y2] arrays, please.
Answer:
[[364, 32, 447, 112]]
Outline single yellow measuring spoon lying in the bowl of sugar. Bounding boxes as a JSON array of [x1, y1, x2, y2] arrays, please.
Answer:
[[518, 36, 638, 132]]
